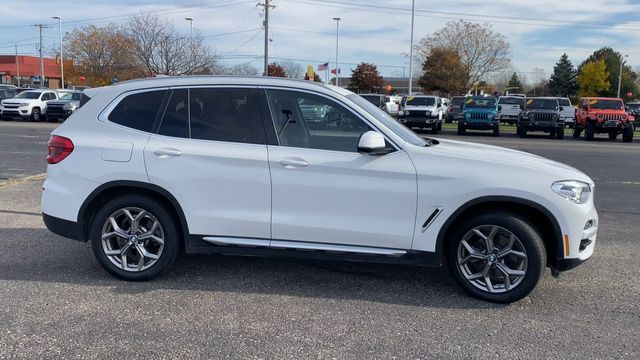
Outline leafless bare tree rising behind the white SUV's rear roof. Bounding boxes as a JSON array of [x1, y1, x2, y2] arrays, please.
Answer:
[[126, 13, 215, 76]]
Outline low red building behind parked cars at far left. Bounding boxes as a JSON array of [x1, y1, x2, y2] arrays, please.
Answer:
[[0, 55, 61, 89]]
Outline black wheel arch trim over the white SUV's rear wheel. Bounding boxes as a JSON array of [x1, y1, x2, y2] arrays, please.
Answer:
[[78, 180, 189, 244]]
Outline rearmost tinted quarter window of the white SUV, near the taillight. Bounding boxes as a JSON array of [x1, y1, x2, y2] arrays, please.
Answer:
[[109, 90, 166, 132]]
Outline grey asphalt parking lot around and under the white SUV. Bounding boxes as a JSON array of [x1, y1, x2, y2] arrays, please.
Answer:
[[0, 122, 640, 359]]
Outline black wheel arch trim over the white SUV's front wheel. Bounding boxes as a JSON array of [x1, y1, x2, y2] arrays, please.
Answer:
[[436, 196, 563, 267]]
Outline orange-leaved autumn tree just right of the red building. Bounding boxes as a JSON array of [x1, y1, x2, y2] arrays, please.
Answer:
[[64, 25, 142, 86]]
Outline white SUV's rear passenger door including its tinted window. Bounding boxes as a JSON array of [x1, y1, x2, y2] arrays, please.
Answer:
[[145, 87, 271, 240]]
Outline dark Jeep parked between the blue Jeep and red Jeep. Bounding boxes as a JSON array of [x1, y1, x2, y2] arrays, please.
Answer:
[[516, 97, 564, 140]]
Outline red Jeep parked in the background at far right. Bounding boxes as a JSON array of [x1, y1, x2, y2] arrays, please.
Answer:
[[573, 97, 635, 142]]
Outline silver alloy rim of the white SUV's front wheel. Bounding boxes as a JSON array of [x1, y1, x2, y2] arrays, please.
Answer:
[[457, 225, 527, 293]]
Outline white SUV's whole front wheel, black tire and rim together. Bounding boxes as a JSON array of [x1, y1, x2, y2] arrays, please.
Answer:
[[445, 211, 547, 303]]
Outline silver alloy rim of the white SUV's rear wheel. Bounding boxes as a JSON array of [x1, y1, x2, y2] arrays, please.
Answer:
[[101, 207, 165, 272]]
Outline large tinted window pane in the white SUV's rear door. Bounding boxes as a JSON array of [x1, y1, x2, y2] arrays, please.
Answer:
[[189, 88, 266, 144]]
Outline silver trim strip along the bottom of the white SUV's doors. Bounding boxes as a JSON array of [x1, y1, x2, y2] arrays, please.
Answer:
[[202, 236, 407, 257]]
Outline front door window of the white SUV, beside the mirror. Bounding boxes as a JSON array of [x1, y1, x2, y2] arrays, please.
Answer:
[[267, 90, 371, 152]]
